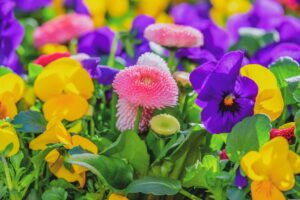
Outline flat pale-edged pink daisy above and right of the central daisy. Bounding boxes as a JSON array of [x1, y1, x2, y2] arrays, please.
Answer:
[[144, 23, 203, 48]]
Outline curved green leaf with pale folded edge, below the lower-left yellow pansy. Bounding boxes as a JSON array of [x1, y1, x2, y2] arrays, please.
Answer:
[[67, 153, 133, 190]]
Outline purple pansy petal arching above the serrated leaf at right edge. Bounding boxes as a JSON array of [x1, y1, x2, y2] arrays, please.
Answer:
[[251, 42, 300, 67]]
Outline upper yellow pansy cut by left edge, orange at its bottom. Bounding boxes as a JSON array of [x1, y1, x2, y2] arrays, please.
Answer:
[[0, 73, 25, 119]]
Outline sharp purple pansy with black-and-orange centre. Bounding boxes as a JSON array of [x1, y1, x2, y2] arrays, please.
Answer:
[[190, 51, 258, 133]]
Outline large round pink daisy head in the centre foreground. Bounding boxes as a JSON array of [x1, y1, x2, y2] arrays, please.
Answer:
[[113, 65, 178, 108]]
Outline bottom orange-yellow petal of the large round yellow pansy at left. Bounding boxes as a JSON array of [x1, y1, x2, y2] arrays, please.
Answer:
[[43, 94, 88, 121]]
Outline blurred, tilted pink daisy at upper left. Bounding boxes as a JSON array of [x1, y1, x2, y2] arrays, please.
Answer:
[[33, 13, 94, 47]]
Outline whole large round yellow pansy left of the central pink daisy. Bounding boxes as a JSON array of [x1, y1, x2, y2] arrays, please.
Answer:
[[34, 58, 94, 121]]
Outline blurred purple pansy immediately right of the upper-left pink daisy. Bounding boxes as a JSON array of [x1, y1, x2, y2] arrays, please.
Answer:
[[77, 27, 121, 57]]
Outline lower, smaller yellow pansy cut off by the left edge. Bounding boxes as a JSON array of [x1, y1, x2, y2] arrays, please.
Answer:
[[0, 121, 20, 156]]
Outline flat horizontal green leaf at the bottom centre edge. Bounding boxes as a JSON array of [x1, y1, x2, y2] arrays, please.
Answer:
[[126, 177, 181, 196]]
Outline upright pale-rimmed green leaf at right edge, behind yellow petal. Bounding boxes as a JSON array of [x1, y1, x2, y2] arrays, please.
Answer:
[[270, 57, 300, 105]]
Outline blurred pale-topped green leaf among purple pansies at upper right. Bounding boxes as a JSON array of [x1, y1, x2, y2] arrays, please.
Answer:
[[230, 28, 279, 56]]
